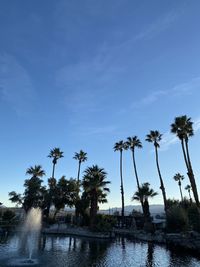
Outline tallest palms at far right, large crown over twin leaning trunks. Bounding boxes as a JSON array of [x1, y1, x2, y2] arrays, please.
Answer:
[[171, 115, 200, 207]]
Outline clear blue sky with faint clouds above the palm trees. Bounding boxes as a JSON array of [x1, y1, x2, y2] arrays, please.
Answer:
[[0, 0, 200, 211]]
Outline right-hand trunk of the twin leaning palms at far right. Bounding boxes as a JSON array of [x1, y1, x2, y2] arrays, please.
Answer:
[[185, 140, 200, 208]]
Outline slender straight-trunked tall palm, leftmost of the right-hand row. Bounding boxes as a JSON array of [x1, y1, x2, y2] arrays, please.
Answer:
[[114, 140, 128, 224]]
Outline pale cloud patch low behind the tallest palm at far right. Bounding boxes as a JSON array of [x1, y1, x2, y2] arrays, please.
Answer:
[[160, 118, 200, 151]]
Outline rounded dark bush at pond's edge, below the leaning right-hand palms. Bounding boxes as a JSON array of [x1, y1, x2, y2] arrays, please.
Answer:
[[166, 206, 189, 233]]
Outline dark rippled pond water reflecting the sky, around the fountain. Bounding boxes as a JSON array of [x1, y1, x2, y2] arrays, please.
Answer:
[[0, 235, 200, 267]]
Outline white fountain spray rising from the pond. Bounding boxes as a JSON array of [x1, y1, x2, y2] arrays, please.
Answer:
[[9, 208, 41, 266]]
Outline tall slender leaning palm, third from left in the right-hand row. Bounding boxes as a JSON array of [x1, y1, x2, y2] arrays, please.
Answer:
[[146, 130, 167, 211]]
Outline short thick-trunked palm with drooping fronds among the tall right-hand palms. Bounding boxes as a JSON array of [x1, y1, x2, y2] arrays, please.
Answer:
[[132, 183, 158, 221]]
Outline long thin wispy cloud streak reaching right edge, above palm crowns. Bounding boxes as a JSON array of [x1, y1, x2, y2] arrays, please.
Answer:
[[131, 77, 200, 109]]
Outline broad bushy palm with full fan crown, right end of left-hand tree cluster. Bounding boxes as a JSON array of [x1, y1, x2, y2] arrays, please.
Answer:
[[82, 165, 110, 227]]
